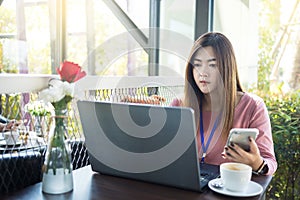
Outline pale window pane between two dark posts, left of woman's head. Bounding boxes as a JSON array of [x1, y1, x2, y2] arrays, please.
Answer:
[[159, 0, 195, 76]]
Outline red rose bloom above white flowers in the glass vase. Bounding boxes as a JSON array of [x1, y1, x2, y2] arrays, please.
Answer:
[[56, 61, 86, 83]]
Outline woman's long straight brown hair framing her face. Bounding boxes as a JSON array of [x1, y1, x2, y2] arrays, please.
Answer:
[[183, 32, 243, 137]]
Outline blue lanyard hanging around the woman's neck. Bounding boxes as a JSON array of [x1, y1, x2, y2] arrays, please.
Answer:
[[200, 103, 222, 162]]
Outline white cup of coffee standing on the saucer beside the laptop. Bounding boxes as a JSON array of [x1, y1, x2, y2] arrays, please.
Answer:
[[220, 162, 252, 192]]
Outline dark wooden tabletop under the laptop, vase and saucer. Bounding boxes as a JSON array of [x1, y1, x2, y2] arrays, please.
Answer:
[[0, 166, 272, 200]]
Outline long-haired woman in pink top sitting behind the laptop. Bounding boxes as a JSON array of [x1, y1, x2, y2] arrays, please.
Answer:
[[172, 33, 277, 175]]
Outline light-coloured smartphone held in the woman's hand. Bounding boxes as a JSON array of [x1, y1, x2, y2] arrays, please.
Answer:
[[226, 128, 258, 152]]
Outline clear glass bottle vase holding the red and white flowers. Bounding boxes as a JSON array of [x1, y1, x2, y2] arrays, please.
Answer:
[[42, 110, 73, 194]]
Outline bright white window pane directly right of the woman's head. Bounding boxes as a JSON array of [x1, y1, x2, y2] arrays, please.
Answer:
[[213, 0, 259, 87]]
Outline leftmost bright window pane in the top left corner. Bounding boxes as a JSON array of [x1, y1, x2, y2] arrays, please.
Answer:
[[0, 0, 50, 73]]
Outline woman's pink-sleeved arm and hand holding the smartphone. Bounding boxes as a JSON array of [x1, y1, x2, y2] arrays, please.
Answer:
[[224, 98, 277, 175]]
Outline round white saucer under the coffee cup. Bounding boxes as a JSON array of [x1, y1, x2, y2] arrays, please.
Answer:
[[208, 178, 263, 197]]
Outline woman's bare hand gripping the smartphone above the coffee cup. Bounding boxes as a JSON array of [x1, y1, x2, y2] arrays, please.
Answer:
[[222, 137, 263, 171]]
